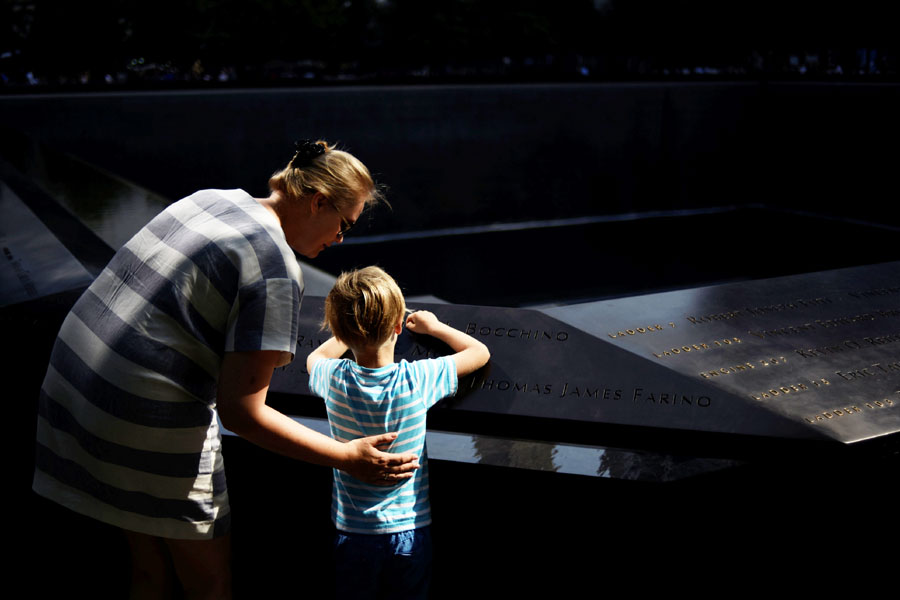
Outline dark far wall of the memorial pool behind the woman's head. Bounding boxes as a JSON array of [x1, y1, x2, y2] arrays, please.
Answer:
[[0, 82, 900, 233]]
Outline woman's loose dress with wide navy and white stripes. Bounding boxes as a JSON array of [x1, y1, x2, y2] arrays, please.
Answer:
[[34, 190, 303, 539]]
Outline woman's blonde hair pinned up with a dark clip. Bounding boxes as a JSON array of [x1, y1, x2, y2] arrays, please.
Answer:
[[269, 140, 384, 209]]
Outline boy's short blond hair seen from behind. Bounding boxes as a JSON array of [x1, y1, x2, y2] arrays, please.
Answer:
[[325, 267, 406, 348]]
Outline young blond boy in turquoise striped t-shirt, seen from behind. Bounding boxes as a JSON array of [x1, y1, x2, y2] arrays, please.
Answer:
[[306, 267, 490, 598]]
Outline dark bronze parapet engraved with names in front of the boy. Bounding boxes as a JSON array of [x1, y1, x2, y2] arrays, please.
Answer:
[[270, 262, 900, 460]]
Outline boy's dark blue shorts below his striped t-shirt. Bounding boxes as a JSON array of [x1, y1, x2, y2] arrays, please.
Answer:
[[334, 526, 431, 600]]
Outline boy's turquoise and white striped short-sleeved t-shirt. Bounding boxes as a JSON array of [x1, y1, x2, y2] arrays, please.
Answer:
[[309, 356, 458, 534]]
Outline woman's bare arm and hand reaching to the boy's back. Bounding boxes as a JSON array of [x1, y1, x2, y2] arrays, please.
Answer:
[[217, 351, 419, 485]]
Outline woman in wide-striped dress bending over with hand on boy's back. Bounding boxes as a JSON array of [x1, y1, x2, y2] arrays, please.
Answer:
[[33, 141, 418, 598]]
